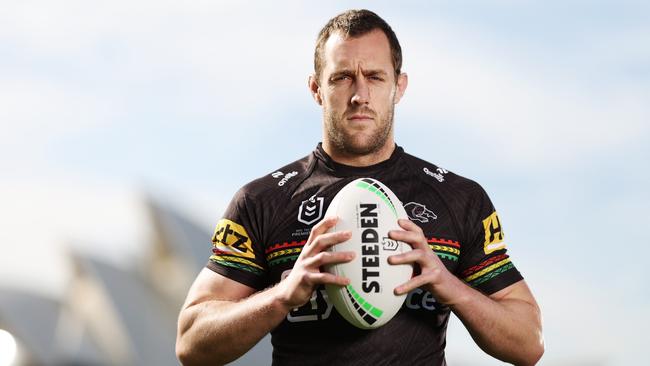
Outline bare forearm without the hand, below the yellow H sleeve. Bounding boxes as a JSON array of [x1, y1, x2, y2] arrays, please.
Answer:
[[450, 280, 544, 365]]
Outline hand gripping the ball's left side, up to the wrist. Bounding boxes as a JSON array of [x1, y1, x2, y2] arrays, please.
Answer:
[[277, 217, 354, 311]]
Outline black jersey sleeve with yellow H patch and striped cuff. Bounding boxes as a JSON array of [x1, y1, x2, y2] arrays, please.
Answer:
[[459, 185, 523, 295]]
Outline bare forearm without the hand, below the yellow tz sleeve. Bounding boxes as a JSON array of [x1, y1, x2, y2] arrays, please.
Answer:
[[176, 268, 288, 365]]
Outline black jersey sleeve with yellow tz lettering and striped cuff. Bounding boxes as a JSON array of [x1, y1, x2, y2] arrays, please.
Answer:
[[207, 189, 268, 290]]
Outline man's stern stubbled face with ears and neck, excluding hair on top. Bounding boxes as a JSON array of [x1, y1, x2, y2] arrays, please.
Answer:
[[310, 29, 406, 157]]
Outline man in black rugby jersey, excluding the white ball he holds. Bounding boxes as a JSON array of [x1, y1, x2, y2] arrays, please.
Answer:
[[176, 10, 544, 365]]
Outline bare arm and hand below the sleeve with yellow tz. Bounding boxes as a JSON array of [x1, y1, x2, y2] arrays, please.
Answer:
[[176, 218, 354, 365]]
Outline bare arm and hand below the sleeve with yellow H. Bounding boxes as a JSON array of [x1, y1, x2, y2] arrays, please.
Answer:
[[389, 220, 544, 365]]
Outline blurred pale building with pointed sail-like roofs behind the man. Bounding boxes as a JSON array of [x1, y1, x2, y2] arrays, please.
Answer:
[[0, 199, 271, 366]]
